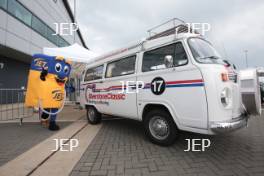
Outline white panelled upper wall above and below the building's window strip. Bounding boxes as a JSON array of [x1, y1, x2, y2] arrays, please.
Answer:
[[0, 0, 81, 59]]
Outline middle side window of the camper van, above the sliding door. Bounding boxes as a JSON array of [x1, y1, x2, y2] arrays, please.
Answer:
[[106, 56, 136, 78]]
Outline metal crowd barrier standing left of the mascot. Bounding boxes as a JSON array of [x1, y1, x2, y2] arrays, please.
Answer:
[[0, 89, 34, 124]]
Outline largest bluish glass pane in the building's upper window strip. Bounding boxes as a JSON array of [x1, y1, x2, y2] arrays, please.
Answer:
[[8, 0, 32, 26]]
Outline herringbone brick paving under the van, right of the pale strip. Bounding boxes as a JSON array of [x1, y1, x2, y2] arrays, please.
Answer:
[[71, 115, 264, 176]]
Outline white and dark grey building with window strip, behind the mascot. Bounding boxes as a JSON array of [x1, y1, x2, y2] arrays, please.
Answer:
[[0, 0, 87, 89]]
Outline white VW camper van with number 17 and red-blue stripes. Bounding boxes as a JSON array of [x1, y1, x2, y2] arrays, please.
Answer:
[[81, 19, 260, 145]]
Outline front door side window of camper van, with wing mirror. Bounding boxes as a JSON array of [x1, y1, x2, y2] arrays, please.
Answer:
[[142, 42, 188, 72]]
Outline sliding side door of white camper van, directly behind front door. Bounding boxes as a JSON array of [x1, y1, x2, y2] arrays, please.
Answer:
[[100, 55, 137, 119]]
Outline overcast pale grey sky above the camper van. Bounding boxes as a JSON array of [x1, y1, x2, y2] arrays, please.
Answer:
[[69, 0, 264, 68]]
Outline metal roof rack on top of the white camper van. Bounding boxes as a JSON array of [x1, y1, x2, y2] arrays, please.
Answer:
[[147, 18, 199, 40]]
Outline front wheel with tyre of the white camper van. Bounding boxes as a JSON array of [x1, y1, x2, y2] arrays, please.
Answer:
[[144, 110, 178, 146]]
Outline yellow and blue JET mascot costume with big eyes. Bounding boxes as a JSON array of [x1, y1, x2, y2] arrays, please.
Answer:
[[25, 54, 71, 131]]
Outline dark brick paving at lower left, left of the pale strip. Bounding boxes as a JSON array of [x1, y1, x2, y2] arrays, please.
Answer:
[[0, 122, 70, 166]]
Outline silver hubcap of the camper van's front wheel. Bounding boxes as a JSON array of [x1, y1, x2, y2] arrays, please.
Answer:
[[149, 116, 169, 140]]
